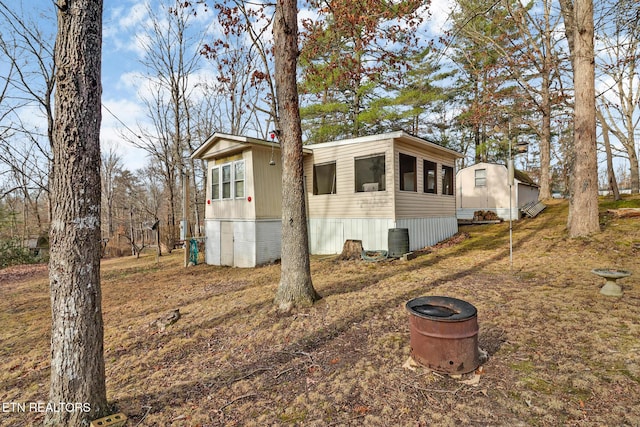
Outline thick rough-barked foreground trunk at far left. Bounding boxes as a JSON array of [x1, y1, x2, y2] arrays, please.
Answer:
[[46, 0, 107, 426]]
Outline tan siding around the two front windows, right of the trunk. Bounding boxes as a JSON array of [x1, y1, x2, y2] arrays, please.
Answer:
[[304, 140, 393, 218]]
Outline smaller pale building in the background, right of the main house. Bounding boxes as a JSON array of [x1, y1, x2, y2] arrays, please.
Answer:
[[456, 162, 540, 220]]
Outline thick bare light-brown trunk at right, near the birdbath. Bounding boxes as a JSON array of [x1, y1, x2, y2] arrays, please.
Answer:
[[560, 0, 600, 237]]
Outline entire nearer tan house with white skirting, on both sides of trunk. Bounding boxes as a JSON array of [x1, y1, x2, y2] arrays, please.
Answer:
[[192, 131, 461, 267]]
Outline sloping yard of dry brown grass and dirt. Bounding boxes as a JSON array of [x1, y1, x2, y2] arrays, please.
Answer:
[[0, 199, 640, 426]]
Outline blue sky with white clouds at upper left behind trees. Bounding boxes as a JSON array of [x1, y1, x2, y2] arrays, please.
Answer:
[[0, 0, 458, 170]]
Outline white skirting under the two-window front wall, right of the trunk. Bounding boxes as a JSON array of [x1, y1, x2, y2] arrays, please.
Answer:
[[309, 218, 394, 255]]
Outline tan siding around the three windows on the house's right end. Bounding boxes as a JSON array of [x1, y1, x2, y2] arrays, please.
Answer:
[[393, 142, 456, 218]]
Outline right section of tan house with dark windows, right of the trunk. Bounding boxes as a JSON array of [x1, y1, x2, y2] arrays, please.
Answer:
[[304, 131, 461, 254]]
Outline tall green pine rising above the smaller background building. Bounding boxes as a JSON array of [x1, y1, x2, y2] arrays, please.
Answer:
[[449, 0, 525, 162]]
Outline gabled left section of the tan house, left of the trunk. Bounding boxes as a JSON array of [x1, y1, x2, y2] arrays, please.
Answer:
[[191, 133, 304, 267]]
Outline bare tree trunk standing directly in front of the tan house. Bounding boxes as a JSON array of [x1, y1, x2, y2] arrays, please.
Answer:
[[273, 0, 320, 311]]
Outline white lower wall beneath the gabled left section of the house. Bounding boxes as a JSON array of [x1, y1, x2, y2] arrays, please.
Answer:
[[205, 219, 281, 267]]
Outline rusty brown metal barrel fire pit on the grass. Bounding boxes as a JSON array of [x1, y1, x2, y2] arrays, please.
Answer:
[[406, 296, 480, 374]]
